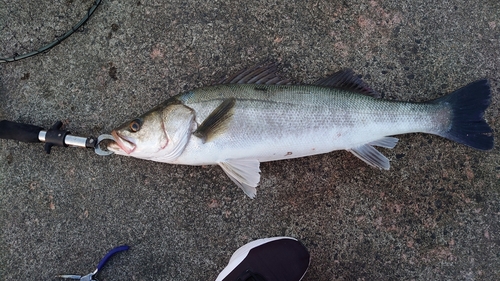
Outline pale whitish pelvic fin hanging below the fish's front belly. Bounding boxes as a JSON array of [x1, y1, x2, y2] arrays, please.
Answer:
[[218, 159, 260, 199]]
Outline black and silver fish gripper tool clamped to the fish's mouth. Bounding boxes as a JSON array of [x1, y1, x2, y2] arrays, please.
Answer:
[[0, 120, 113, 156]]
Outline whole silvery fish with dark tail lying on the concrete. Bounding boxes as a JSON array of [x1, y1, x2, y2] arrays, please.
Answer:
[[107, 63, 494, 198]]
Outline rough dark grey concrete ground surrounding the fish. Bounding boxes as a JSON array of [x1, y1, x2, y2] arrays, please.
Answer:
[[0, 0, 500, 281]]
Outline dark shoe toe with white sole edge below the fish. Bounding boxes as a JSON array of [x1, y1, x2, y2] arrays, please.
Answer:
[[215, 237, 310, 281]]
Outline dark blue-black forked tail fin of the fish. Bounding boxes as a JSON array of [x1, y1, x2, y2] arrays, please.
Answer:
[[432, 79, 493, 150]]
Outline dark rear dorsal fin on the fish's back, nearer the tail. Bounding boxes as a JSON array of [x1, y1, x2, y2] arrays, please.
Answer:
[[314, 69, 381, 98]]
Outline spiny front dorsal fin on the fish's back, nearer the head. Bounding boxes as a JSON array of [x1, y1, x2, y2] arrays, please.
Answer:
[[219, 61, 291, 85]]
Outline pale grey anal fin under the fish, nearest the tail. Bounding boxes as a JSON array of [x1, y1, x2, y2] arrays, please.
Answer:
[[349, 137, 398, 170]]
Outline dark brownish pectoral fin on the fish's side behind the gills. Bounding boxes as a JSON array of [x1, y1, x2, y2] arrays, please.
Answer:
[[193, 98, 236, 143]]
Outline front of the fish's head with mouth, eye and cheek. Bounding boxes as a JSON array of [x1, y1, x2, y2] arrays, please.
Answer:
[[107, 110, 169, 159]]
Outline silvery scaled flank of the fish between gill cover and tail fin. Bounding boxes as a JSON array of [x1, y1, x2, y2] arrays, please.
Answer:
[[177, 84, 447, 160]]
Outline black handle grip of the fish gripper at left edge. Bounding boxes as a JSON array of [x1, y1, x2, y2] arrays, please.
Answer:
[[0, 120, 43, 142]]
